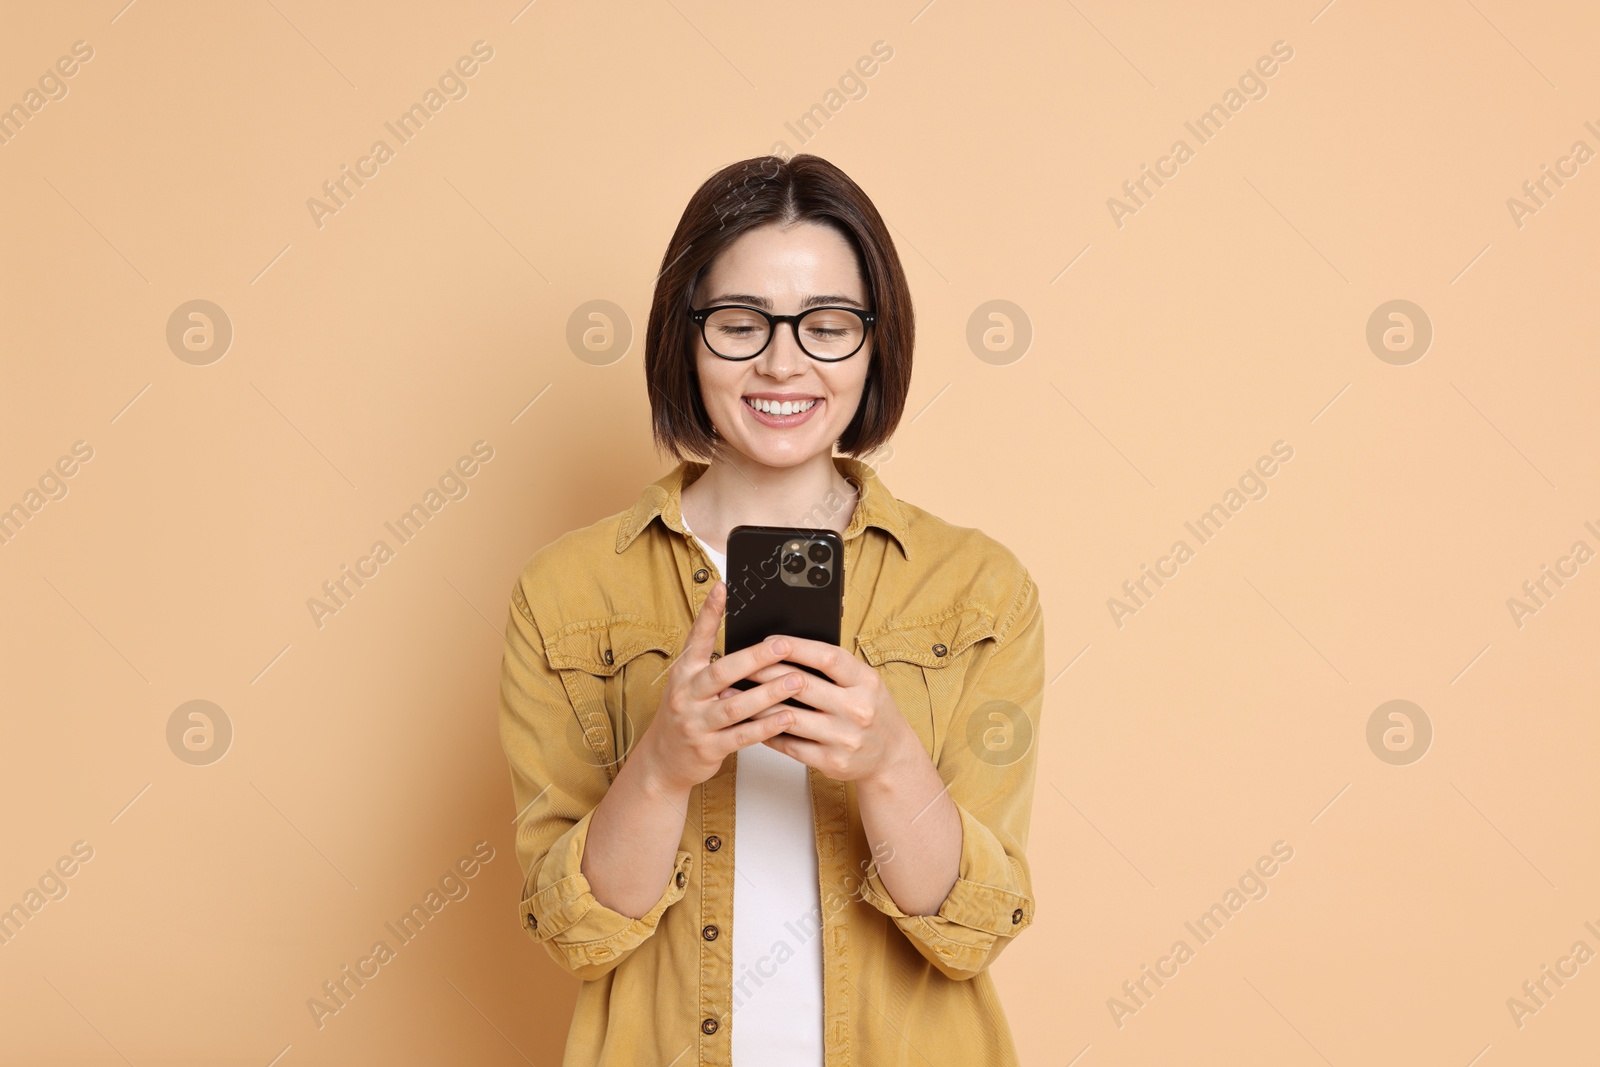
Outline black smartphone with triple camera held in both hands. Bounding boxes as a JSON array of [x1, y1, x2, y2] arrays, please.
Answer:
[[723, 526, 845, 710]]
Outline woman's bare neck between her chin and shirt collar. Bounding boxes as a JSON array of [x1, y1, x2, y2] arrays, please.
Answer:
[[680, 453, 859, 552]]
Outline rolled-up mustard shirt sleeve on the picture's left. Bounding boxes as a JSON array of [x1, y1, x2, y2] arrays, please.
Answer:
[[499, 581, 694, 981]]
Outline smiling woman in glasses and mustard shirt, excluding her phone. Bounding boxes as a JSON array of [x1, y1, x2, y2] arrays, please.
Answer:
[[501, 155, 1045, 1067]]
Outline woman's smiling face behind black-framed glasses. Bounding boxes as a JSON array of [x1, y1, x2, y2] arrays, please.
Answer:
[[694, 222, 872, 467]]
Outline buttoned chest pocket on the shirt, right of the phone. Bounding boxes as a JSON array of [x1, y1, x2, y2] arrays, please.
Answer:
[[856, 600, 995, 763]]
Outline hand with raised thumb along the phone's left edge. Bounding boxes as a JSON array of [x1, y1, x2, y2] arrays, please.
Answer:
[[632, 581, 800, 793]]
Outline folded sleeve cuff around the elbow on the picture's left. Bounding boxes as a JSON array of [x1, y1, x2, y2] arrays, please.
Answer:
[[522, 811, 694, 969]]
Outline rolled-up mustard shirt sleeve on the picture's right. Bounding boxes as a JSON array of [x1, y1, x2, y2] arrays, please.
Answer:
[[861, 571, 1045, 981]]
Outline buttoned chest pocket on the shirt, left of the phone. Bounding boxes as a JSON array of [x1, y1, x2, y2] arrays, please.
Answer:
[[544, 613, 683, 779]]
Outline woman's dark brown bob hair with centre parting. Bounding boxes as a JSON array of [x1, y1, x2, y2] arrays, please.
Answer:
[[645, 154, 915, 461]]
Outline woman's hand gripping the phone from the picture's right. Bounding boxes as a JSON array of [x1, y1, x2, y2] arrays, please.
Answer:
[[723, 635, 923, 782]]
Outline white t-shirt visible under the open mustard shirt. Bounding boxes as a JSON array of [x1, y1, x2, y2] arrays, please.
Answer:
[[683, 518, 822, 1067]]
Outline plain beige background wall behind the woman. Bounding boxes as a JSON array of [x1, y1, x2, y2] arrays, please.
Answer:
[[0, 0, 1600, 1067]]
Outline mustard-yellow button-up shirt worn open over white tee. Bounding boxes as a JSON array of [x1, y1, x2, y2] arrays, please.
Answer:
[[499, 456, 1045, 1067]]
